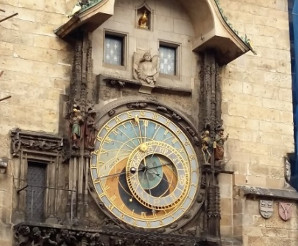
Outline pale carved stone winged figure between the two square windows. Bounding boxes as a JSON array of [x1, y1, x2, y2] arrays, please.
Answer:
[[133, 51, 159, 86]]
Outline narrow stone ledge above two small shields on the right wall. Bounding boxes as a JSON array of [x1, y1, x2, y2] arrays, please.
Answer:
[[239, 186, 298, 202]]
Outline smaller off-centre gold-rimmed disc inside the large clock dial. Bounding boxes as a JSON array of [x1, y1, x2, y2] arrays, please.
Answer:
[[126, 141, 190, 210]]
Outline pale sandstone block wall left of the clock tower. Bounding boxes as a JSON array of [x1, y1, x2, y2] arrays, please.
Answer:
[[0, 0, 75, 246]]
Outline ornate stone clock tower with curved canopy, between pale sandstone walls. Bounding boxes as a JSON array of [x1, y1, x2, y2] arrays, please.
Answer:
[[13, 0, 251, 246]]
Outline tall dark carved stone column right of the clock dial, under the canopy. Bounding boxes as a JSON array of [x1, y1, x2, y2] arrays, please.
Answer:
[[199, 51, 222, 241]]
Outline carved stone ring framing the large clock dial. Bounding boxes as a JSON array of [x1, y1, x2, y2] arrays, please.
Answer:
[[91, 97, 206, 233]]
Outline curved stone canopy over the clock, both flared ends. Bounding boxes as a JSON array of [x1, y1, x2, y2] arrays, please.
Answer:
[[55, 0, 253, 65]]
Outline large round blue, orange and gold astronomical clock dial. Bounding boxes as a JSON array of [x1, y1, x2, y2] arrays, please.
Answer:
[[90, 106, 200, 229]]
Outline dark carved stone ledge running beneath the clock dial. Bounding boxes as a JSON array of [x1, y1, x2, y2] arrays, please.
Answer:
[[13, 222, 217, 246]]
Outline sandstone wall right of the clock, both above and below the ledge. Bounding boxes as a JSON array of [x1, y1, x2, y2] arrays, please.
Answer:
[[220, 0, 298, 245]]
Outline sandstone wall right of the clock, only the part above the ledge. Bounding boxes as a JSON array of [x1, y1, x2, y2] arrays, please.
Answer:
[[220, 0, 294, 188]]
